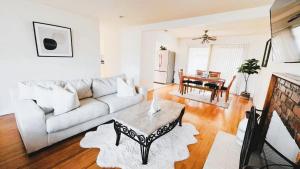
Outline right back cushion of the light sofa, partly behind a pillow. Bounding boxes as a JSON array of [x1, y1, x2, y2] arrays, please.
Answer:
[[92, 75, 125, 98]]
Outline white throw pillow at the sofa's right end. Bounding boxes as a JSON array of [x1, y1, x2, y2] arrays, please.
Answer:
[[117, 78, 136, 97]]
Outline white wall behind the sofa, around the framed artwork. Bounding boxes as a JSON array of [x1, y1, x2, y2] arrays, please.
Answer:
[[0, 0, 100, 115]]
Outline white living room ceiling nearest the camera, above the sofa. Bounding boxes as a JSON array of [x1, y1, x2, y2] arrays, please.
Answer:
[[30, 0, 273, 25]]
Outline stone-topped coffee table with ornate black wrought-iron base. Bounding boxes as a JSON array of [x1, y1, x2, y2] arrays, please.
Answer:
[[114, 100, 185, 164]]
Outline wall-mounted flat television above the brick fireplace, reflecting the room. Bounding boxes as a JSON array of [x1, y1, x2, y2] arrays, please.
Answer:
[[270, 0, 300, 63]]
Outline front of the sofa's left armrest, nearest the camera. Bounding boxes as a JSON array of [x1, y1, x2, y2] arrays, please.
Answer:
[[14, 100, 48, 153]]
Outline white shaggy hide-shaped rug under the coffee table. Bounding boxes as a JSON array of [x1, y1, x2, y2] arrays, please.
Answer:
[[80, 123, 199, 169]]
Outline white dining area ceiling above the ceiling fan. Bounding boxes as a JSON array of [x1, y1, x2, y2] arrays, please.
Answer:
[[168, 17, 270, 38]]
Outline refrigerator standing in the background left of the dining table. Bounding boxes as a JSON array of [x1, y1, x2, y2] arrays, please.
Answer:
[[154, 50, 175, 84]]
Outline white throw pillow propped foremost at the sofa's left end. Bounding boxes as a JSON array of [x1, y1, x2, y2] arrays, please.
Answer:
[[52, 83, 80, 115]]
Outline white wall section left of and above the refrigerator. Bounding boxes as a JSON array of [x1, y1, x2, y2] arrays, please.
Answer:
[[140, 31, 177, 89]]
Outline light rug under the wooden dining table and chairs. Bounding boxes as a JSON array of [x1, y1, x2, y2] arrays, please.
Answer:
[[169, 90, 232, 109]]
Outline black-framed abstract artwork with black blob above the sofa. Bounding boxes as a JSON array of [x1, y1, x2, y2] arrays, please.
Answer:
[[33, 22, 73, 57]]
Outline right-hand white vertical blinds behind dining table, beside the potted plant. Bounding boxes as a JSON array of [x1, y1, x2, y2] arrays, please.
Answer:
[[209, 45, 244, 94]]
